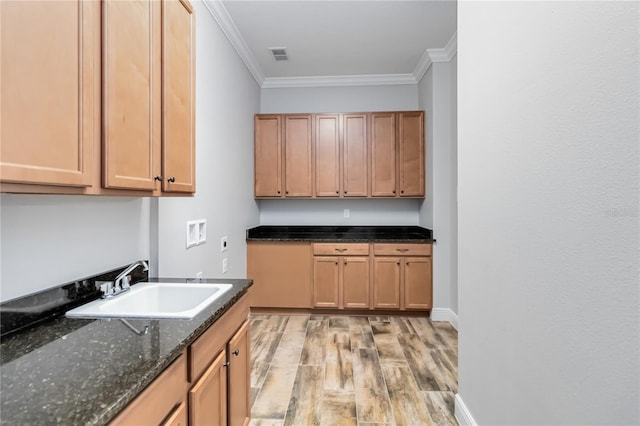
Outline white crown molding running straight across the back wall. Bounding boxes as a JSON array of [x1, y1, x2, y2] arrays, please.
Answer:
[[262, 74, 416, 89]]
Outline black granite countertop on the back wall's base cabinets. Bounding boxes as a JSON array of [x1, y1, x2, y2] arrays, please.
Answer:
[[247, 226, 434, 243]]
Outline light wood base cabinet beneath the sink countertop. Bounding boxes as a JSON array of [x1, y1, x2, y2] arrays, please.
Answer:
[[111, 295, 250, 426]]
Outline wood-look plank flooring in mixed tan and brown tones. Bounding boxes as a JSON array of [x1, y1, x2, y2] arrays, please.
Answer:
[[250, 314, 458, 426]]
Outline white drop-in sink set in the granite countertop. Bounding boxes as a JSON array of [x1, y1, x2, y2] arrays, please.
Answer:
[[65, 282, 231, 319]]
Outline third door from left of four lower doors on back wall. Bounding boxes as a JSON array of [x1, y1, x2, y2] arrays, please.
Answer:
[[373, 257, 401, 309]]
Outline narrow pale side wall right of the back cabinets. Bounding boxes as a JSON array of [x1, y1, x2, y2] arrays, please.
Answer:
[[418, 56, 458, 321]]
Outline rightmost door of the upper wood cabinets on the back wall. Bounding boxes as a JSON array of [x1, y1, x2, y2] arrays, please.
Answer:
[[398, 111, 425, 197]]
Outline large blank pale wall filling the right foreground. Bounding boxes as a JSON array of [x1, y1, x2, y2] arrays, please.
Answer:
[[457, 2, 640, 425]]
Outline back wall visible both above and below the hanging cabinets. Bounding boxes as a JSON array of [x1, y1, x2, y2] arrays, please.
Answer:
[[259, 85, 419, 226]]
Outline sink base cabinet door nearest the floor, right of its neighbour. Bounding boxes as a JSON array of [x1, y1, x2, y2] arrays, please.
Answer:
[[227, 321, 251, 426]]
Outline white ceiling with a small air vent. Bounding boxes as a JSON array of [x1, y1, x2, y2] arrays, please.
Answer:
[[207, 0, 457, 87]]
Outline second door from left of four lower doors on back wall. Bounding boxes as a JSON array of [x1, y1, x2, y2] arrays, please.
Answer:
[[341, 256, 370, 309]]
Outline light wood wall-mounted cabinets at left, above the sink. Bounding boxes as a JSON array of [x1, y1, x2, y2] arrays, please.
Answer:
[[0, 0, 195, 196]]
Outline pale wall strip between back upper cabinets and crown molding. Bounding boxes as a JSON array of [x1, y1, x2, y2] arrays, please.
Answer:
[[260, 84, 418, 114]]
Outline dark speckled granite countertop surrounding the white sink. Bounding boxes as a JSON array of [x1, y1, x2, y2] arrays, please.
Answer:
[[0, 279, 252, 425]]
